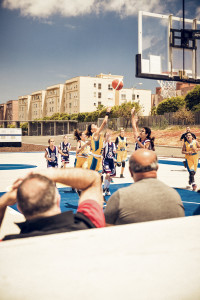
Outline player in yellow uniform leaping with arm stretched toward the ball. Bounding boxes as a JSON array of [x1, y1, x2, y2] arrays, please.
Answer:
[[86, 107, 111, 173]]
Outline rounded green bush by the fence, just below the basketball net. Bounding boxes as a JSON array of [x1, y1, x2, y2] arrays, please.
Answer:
[[156, 97, 185, 115]]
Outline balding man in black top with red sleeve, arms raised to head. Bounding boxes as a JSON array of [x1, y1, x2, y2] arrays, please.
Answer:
[[0, 168, 105, 240]]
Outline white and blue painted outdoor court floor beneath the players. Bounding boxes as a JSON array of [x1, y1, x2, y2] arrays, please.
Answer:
[[0, 152, 200, 216]]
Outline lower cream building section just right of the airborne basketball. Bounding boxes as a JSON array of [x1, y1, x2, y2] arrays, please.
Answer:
[[119, 88, 151, 116]]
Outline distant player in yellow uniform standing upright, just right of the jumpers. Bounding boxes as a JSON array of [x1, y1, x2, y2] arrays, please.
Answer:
[[115, 128, 128, 178]]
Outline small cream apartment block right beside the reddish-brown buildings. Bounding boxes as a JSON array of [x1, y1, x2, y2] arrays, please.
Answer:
[[18, 95, 31, 121]]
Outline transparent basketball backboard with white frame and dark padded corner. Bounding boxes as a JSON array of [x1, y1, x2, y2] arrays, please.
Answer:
[[136, 11, 200, 83]]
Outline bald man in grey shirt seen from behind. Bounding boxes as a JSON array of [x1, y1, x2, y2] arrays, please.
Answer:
[[104, 149, 185, 225]]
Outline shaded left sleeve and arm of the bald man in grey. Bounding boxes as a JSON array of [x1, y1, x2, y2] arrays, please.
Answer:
[[104, 191, 119, 226]]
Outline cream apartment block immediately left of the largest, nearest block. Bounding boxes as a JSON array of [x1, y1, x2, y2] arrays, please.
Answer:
[[44, 84, 64, 117]]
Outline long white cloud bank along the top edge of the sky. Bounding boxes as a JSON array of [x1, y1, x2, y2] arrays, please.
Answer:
[[2, 0, 165, 18]]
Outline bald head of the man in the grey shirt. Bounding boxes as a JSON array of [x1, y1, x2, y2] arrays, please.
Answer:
[[129, 149, 158, 181]]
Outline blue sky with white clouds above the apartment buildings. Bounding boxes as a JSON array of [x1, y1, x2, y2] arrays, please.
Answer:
[[0, 0, 200, 103]]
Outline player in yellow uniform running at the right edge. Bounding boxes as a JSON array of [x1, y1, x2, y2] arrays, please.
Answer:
[[182, 132, 200, 191]]
